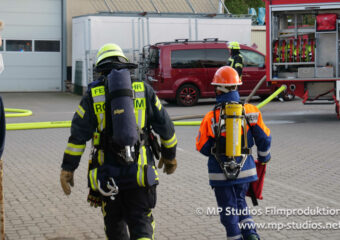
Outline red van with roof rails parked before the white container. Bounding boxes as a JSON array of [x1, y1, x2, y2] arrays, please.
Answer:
[[144, 39, 282, 106]]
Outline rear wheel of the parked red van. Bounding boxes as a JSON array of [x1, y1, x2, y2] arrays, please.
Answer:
[[176, 84, 200, 107]]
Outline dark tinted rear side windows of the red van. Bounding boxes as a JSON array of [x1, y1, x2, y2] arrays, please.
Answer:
[[171, 49, 229, 68]]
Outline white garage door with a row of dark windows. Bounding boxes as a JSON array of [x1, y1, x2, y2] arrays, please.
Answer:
[[0, 0, 62, 92]]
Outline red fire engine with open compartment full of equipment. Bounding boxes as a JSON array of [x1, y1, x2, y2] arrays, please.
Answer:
[[265, 0, 340, 118]]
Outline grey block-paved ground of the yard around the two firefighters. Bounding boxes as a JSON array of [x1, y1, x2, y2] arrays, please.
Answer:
[[1, 93, 340, 240]]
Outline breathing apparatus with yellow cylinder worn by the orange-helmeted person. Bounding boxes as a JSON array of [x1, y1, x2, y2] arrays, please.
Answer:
[[211, 102, 251, 180]]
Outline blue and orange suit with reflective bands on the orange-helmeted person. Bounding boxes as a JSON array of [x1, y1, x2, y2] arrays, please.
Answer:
[[196, 91, 271, 240]]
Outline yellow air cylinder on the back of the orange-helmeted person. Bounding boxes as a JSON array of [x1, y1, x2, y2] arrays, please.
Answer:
[[225, 103, 243, 157]]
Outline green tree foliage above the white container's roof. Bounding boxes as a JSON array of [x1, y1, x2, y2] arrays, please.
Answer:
[[225, 0, 265, 14]]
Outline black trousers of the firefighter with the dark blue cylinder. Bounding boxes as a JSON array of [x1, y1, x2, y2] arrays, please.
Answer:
[[102, 186, 156, 240]]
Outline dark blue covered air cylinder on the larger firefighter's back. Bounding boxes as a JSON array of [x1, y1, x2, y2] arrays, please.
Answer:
[[107, 69, 138, 147]]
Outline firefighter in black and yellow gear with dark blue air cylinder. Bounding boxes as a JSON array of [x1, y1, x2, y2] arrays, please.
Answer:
[[60, 43, 177, 240]]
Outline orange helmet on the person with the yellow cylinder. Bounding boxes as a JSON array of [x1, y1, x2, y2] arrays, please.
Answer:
[[211, 66, 242, 86]]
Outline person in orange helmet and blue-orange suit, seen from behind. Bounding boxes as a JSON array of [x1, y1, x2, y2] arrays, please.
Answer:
[[196, 66, 271, 240]]
